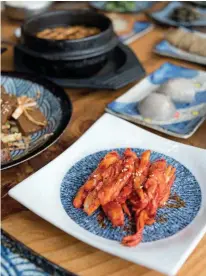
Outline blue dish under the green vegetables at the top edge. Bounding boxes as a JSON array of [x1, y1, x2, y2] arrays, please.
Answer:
[[89, 1, 154, 13]]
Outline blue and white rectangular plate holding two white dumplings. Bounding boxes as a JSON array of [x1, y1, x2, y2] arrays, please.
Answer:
[[106, 63, 206, 138]]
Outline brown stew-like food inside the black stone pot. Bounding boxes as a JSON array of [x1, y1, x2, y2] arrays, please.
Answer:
[[36, 26, 101, 40]]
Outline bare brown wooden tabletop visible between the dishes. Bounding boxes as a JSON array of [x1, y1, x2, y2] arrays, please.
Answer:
[[1, 2, 206, 276]]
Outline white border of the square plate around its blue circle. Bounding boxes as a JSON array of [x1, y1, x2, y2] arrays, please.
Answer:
[[9, 114, 206, 275]]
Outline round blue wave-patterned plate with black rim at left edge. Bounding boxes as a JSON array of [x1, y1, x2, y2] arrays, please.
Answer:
[[1, 72, 72, 169]]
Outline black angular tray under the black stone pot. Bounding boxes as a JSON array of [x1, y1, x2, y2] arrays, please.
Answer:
[[14, 43, 145, 90]]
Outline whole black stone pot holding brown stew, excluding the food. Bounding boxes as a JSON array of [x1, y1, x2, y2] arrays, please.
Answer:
[[18, 10, 119, 77]]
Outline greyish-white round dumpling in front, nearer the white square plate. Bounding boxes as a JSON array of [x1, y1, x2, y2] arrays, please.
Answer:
[[138, 93, 176, 121]]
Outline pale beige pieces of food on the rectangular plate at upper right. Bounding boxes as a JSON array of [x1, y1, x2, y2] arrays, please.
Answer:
[[165, 28, 206, 57]]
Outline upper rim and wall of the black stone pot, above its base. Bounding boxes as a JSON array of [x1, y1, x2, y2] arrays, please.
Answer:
[[21, 10, 118, 60]]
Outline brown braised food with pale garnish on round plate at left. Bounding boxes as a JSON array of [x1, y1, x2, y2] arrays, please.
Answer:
[[1, 87, 47, 163]]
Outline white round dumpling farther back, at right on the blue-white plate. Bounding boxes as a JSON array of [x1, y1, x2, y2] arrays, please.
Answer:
[[158, 78, 195, 103]]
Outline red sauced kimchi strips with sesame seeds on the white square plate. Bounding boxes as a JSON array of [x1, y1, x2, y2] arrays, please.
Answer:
[[73, 149, 175, 246]]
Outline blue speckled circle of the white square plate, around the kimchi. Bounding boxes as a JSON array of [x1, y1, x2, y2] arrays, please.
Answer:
[[60, 148, 202, 242]]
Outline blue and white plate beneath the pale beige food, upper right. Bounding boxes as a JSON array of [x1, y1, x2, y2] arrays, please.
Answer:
[[153, 28, 206, 65]]
